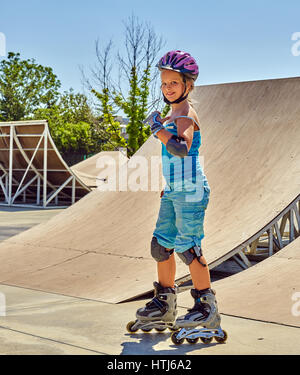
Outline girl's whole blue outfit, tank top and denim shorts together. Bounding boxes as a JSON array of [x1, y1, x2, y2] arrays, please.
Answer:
[[153, 116, 210, 253]]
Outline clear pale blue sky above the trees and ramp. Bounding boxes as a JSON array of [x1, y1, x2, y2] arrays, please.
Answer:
[[0, 0, 300, 91]]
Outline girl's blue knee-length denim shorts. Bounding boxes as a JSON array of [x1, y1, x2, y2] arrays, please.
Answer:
[[153, 184, 210, 253]]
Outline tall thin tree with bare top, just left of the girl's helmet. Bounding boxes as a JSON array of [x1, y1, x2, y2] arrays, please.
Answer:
[[114, 15, 163, 155]]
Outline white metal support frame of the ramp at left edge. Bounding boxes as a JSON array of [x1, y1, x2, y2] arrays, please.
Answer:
[[0, 121, 89, 208]]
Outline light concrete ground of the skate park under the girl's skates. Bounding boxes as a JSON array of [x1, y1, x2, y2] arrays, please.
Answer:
[[0, 208, 300, 355]]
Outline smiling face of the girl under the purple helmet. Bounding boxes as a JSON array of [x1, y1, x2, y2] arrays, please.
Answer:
[[160, 69, 189, 102]]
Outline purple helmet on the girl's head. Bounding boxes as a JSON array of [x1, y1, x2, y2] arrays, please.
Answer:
[[156, 51, 199, 81]]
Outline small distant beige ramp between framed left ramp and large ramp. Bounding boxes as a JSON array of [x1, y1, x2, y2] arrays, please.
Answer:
[[71, 151, 128, 189]]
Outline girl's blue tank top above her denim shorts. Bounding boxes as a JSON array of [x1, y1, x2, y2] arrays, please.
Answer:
[[162, 116, 208, 189]]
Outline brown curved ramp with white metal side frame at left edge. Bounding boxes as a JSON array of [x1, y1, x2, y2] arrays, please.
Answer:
[[0, 120, 90, 207]]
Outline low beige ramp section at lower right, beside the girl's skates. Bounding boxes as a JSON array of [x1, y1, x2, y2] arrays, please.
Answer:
[[211, 237, 300, 327]]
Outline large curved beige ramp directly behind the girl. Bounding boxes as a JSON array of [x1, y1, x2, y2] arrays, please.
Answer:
[[0, 78, 300, 302]]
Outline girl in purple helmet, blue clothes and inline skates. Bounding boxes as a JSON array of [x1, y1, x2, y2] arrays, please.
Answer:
[[130, 51, 220, 332]]
